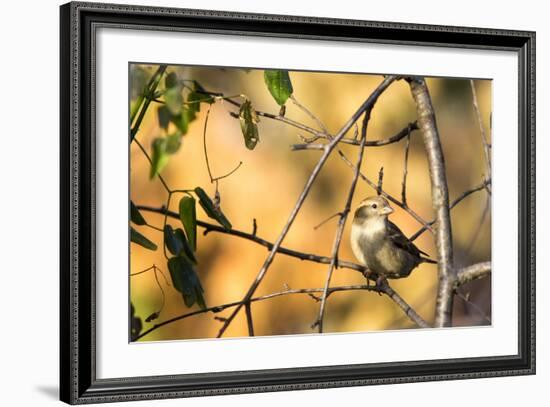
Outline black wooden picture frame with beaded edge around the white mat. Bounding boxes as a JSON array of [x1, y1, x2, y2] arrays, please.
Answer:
[[60, 2, 535, 404]]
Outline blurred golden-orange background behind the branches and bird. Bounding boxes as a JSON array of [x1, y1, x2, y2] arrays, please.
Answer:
[[129, 65, 491, 341]]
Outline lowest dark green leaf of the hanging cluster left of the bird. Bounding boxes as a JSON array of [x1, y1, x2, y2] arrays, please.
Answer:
[[168, 256, 206, 309]]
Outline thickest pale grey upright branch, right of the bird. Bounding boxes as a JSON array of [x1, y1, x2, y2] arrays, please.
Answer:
[[409, 77, 455, 327]]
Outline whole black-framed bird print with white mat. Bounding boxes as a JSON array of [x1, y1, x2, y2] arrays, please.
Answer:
[[60, 3, 535, 404]]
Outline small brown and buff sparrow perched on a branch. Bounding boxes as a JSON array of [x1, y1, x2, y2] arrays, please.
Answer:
[[351, 196, 437, 283]]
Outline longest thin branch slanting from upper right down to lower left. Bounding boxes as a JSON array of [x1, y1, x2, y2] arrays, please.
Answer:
[[218, 76, 397, 337]]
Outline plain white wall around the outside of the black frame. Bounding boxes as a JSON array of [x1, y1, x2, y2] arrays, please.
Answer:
[[0, 0, 550, 407]]
